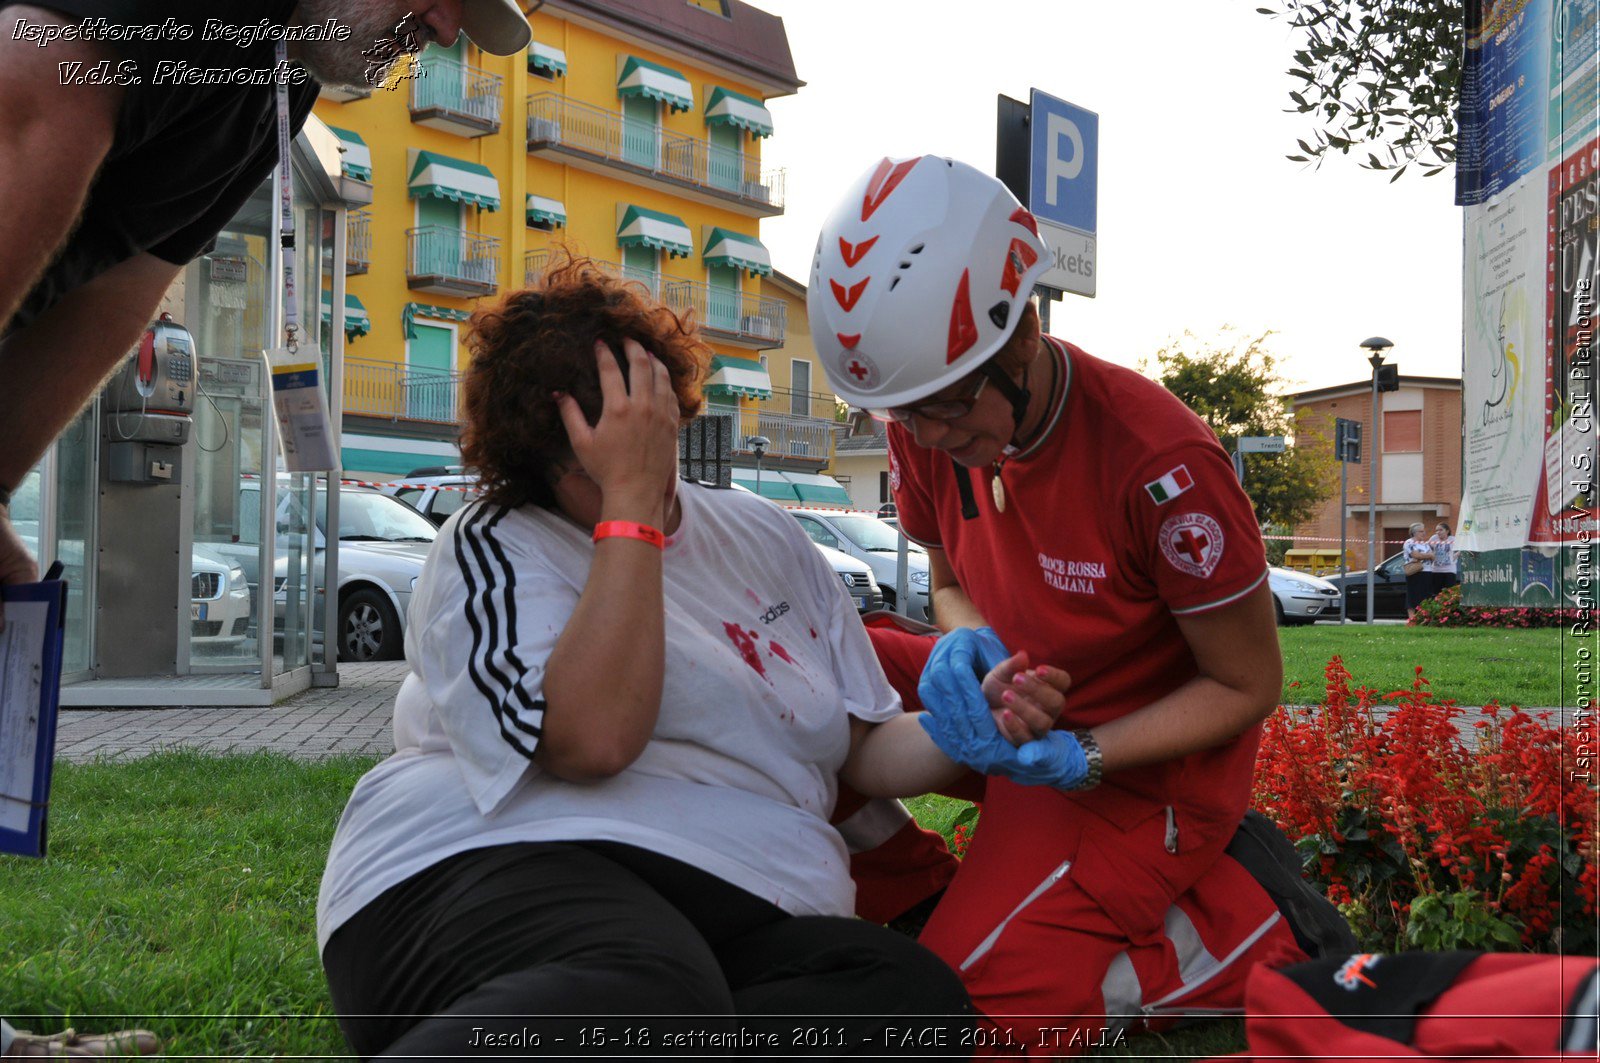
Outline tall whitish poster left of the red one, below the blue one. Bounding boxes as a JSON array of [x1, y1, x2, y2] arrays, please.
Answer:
[[1456, 174, 1546, 552]]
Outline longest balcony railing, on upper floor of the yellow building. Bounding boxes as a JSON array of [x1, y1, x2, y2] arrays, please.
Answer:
[[528, 93, 784, 215]]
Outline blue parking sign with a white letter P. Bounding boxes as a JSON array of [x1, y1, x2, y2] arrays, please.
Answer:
[[1027, 88, 1099, 235]]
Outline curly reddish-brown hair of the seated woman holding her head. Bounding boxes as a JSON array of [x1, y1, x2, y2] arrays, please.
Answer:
[[461, 255, 710, 507]]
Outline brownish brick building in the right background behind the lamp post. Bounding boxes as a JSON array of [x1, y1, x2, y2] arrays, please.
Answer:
[[1294, 376, 1461, 567]]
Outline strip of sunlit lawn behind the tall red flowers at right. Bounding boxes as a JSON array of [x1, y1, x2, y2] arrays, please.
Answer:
[[1278, 624, 1592, 708]]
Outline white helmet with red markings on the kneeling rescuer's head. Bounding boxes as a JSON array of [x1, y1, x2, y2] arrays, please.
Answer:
[[806, 155, 1050, 410]]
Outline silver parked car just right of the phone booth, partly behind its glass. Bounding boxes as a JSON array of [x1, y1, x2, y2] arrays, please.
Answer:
[[272, 483, 438, 661]]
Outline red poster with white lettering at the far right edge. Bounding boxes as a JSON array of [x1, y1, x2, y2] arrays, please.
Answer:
[[1528, 139, 1600, 544]]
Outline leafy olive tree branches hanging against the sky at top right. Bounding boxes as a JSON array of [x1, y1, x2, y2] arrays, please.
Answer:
[[1256, 0, 1466, 181]]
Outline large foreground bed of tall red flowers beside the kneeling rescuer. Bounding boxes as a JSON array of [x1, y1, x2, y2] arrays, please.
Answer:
[[1256, 656, 1600, 954]]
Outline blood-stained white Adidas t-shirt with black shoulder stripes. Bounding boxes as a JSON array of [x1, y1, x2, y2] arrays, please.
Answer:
[[317, 483, 901, 948]]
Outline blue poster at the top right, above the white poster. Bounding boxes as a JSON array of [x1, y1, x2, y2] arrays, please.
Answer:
[[1456, 0, 1550, 205]]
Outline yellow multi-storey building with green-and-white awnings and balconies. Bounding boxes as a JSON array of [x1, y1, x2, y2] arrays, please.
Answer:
[[317, 0, 832, 479]]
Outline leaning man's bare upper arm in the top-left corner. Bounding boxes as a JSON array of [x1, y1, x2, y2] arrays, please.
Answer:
[[0, 6, 122, 332]]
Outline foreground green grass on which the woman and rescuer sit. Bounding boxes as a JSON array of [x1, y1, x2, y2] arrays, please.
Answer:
[[0, 752, 1245, 1060]]
